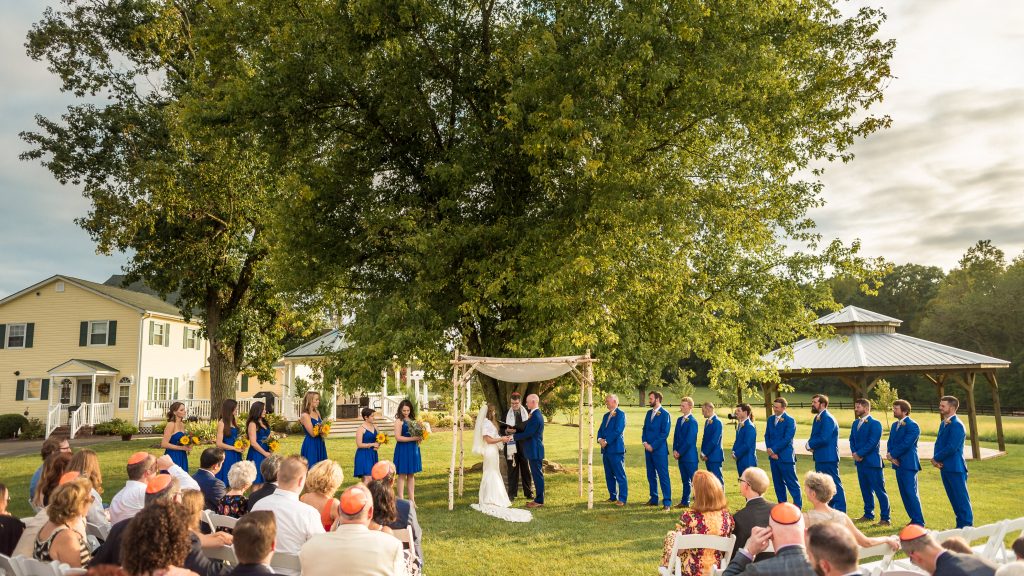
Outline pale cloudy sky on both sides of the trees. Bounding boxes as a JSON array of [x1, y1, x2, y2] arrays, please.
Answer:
[[0, 0, 1024, 297]]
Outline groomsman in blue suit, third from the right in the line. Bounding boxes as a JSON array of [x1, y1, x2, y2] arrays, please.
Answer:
[[850, 398, 892, 526]]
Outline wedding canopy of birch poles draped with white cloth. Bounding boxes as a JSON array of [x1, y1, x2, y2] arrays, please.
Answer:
[[449, 351, 597, 510]]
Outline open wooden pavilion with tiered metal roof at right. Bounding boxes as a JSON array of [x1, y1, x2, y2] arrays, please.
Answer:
[[762, 306, 1010, 459]]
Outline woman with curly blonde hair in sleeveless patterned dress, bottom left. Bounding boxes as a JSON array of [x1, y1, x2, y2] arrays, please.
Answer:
[[32, 470, 92, 568]]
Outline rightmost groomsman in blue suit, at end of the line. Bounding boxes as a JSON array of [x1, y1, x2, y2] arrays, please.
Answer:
[[932, 396, 974, 528]]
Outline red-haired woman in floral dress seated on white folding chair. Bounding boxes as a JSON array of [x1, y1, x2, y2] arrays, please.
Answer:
[[662, 470, 735, 576]]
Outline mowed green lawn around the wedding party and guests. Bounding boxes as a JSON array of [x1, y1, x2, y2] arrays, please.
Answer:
[[0, 407, 1024, 576]]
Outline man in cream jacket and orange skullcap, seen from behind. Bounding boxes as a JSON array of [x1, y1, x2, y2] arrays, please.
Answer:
[[299, 484, 408, 576]]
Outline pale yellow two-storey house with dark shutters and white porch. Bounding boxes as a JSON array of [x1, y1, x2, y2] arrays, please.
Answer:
[[0, 276, 210, 435]]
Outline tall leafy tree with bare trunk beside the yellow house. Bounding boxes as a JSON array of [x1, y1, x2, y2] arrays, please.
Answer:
[[23, 0, 303, 406]]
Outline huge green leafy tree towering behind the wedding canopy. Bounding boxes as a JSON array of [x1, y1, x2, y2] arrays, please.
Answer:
[[210, 0, 893, 412]]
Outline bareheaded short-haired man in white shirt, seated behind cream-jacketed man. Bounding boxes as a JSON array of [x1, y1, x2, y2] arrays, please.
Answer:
[[253, 456, 321, 575]]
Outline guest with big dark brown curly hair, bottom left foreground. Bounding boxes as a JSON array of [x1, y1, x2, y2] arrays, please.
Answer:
[[118, 500, 191, 576]]
